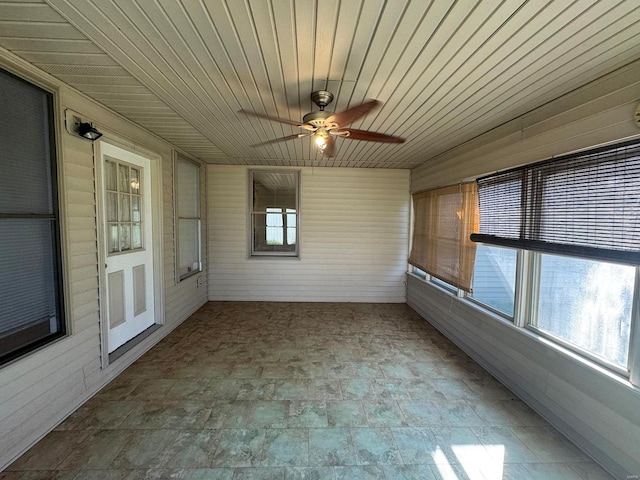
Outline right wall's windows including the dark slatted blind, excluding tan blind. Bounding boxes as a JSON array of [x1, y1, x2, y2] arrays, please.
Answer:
[[414, 141, 640, 378]]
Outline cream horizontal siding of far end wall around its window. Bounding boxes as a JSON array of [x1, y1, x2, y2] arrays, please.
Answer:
[[207, 165, 409, 303]]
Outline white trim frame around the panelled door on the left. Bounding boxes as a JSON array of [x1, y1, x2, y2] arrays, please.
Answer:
[[93, 134, 164, 368]]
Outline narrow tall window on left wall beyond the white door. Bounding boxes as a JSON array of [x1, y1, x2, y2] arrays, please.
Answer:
[[174, 155, 202, 280]]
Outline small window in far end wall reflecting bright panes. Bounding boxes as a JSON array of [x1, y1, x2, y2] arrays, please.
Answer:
[[249, 170, 299, 256]]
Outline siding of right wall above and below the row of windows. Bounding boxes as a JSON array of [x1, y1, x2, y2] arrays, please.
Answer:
[[407, 62, 640, 478]]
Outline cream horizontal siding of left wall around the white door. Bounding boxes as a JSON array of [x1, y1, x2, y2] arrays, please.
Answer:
[[0, 49, 207, 471]]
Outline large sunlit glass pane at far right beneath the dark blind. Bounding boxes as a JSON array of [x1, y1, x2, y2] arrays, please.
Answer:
[[537, 255, 635, 367]]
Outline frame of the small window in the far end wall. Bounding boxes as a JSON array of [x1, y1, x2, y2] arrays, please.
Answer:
[[247, 169, 301, 259]]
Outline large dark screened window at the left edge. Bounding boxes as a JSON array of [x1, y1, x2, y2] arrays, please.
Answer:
[[0, 69, 65, 363]]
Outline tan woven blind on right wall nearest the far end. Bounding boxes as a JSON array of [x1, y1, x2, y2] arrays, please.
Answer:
[[409, 183, 478, 292]]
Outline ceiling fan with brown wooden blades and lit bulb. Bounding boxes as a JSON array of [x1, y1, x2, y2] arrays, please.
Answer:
[[240, 90, 404, 157]]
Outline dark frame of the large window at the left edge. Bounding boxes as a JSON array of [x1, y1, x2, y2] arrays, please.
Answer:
[[0, 65, 66, 369]]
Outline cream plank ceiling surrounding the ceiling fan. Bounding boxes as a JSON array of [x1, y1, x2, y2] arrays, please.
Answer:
[[0, 0, 640, 168]]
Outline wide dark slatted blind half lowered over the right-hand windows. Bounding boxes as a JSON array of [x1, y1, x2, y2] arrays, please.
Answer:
[[471, 142, 640, 265]]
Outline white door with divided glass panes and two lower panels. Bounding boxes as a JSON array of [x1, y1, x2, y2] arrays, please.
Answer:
[[99, 141, 155, 353]]
